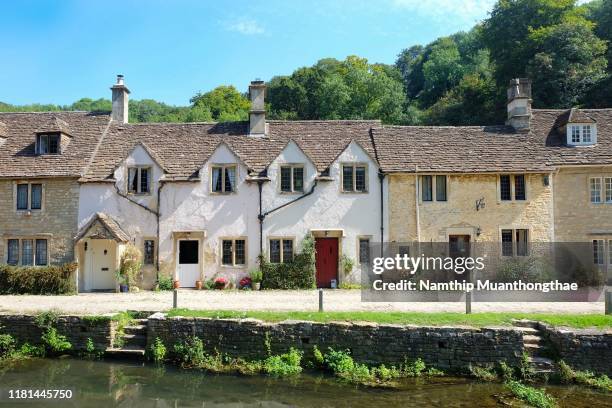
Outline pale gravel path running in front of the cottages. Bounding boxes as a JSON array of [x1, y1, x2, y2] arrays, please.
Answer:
[[0, 290, 604, 314]]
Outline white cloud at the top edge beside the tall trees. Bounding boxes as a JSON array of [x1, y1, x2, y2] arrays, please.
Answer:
[[392, 0, 496, 23]]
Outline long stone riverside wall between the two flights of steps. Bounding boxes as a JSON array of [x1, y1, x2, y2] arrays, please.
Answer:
[[147, 313, 523, 370]]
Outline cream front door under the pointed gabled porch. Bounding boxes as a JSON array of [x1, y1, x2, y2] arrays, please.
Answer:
[[85, 239, 117, 290]]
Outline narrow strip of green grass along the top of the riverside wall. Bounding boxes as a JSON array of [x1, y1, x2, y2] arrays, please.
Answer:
[[168, 309, 612, 329]]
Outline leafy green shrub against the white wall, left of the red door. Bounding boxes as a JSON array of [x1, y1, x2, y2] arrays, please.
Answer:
[[259, 235, 316, 289]]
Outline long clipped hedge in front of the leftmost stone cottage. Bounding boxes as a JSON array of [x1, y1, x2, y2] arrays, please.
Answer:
[[0, 263, 77, 295]]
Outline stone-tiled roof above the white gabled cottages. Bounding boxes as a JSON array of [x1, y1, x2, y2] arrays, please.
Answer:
[[82, 121, 380, 181]]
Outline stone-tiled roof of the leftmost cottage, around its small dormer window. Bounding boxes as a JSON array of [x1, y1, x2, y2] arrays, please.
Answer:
[[0, 112, 110, 177]]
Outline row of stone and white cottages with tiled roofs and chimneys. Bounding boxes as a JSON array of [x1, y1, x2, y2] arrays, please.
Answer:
[[0, 76, 612, 291]]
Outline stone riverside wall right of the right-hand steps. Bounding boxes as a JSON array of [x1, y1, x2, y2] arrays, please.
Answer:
[[540, 324, 612, 375]]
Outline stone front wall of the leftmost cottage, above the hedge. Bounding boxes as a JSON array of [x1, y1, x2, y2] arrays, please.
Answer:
[[0, 178, 79, 264]]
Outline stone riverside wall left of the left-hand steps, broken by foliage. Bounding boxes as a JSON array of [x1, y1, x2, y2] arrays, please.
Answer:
[[0, 315, 116, 352]]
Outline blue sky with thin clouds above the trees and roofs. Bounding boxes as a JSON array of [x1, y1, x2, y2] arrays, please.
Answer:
[[0, 0, 494, 105]]
